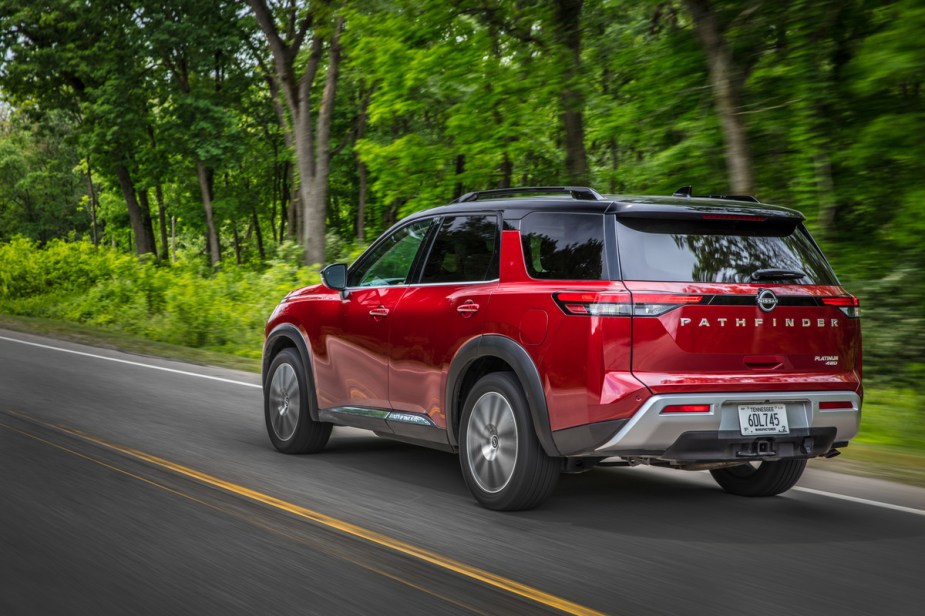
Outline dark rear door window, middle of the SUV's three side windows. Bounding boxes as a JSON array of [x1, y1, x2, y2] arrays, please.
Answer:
[[421, 214, 500, 284]]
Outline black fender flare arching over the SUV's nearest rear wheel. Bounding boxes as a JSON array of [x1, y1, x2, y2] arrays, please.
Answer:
[[446, 334, 562, 457]]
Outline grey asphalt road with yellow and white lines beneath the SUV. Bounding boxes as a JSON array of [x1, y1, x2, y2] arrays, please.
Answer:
[[0, 330, 925, 616]]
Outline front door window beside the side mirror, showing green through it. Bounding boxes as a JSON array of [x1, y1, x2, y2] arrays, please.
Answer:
[[347, 218, 433, 287]]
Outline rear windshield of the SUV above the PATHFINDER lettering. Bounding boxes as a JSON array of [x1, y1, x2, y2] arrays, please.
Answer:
[[617, 218, 838, 285]]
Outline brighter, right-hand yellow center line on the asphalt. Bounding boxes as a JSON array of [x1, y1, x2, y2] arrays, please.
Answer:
[[10, 411, 604, 616]]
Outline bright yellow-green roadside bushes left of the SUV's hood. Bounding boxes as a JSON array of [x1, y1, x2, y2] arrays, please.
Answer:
[[0, 237, 320, 357]]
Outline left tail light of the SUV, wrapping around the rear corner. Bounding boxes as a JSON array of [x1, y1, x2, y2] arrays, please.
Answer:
[[553, 291, 703, 317]]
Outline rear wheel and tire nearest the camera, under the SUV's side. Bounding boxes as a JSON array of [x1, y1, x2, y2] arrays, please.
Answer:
[[459, 372, 560, 511]]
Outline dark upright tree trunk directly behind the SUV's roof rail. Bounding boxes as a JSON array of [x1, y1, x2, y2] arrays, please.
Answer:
[[553, 0, 590, 186]]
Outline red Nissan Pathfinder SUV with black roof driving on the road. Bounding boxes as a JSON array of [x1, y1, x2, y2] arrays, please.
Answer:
[[263, 187, 862, 510]]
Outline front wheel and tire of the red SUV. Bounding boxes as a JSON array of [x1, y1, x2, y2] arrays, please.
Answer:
[[263, 348, 332, 453]]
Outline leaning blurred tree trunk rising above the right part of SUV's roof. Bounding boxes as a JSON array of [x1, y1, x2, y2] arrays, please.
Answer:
[[684, 0, 755, 195]]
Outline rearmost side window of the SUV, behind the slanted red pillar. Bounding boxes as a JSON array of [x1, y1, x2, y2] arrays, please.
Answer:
[[520, 212, 604, 280]]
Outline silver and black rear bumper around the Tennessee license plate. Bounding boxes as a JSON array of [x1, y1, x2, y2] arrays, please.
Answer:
[[548, 391, 861, 462]]
